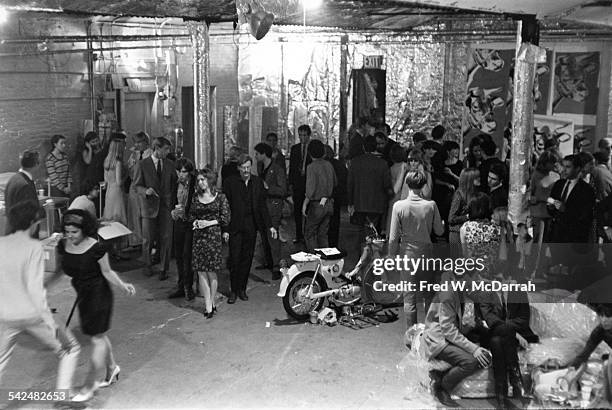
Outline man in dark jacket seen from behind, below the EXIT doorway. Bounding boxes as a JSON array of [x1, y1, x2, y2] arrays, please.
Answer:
[[347, 135, 393, 243]]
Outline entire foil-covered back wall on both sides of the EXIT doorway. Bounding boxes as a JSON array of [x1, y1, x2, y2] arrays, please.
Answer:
[[238, 28, 468, 151]]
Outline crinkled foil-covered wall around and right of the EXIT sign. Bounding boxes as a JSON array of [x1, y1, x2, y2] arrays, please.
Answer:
[[349, 41, 467, 144]]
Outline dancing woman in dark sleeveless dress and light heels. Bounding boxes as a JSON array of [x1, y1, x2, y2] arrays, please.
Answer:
[[58, 209, 136, 401]]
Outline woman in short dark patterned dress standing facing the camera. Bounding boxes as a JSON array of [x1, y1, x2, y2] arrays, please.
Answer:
[[189, 169, 230, 319]]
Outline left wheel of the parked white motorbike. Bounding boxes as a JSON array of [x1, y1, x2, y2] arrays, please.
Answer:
[[283, 272, 324, 321]]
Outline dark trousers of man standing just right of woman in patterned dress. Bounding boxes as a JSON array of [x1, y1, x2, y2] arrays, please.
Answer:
[[229, 217, 257, 293]]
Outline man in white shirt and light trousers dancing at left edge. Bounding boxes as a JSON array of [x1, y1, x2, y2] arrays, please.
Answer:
[[0, 201, 80, 394]]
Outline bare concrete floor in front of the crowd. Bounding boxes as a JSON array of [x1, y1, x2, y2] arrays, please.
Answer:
[[0, 213, 502, 409]]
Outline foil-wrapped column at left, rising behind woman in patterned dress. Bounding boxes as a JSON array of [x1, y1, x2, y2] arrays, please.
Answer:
[[187, 22, 213, 168]]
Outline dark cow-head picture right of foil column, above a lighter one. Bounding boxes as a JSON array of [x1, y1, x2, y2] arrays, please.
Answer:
[[553, 52, 600, 115]]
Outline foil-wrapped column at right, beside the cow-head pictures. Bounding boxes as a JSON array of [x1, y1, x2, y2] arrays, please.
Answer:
[[508, 42, 541, 232]]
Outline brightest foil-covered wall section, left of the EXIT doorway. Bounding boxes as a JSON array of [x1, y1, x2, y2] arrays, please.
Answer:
[[238, 35, 340, 151]]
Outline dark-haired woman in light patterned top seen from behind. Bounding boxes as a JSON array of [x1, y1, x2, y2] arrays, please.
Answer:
[[460, 192, 501, 278]]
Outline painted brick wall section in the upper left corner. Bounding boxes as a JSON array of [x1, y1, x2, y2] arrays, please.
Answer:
[[0, 14, 91, 179]]
